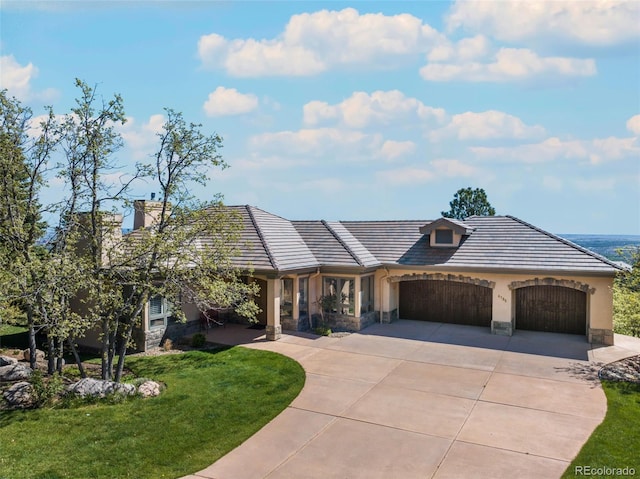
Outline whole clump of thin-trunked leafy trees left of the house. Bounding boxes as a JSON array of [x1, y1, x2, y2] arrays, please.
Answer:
[[0, 80, 258, 381]]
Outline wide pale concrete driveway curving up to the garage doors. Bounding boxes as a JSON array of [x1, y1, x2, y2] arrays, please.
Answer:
[[182, 321, 640, 479]]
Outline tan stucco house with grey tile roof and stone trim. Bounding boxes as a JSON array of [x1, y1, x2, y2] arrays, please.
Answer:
[[85, 202, 621, 349]]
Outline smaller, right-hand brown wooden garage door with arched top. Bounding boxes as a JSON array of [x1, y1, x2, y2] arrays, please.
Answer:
[[516, 286, 587, 334]]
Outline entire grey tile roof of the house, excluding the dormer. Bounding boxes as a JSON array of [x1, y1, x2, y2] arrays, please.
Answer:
[[209, 206, 620, 275]]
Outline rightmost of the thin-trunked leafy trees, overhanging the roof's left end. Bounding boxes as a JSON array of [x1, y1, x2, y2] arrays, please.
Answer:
[[101, 109, 258, 381]]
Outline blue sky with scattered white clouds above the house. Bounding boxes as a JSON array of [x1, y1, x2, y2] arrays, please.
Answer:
[[0, 0, 640, 234]]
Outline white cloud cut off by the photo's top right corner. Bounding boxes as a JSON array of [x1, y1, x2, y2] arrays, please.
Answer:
[[446, 0, 640, 46]]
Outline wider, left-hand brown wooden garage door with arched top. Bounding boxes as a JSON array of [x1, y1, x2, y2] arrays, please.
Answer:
[[399, 280, 491, 326]]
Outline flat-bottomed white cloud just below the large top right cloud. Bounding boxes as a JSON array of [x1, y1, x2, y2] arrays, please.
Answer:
[[420, 48, 596, 82]]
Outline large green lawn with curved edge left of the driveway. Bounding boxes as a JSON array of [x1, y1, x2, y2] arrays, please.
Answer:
[[0, 348, 304, 479]]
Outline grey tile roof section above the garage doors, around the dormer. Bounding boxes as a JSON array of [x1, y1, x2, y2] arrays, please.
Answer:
[[343, 216, 619, 274]]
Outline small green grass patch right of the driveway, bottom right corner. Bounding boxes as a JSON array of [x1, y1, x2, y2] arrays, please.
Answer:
[[562, 381, 640, 478]]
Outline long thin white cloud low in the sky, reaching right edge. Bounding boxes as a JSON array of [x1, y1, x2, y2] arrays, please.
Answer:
[[470, 137, 640, 164]]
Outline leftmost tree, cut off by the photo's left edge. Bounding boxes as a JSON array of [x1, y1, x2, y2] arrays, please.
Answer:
[[0, 90, 56, 367]]
